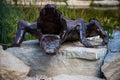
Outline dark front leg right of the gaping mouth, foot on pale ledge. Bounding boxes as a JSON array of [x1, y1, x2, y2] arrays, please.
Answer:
[[75, 19, 94, 47]]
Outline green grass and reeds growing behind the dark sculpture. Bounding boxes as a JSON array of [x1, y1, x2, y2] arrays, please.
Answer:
[[0, 0, 120, 48]]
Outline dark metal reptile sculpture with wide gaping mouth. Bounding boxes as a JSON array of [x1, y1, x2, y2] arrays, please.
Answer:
[[11, 4, 109, 55]]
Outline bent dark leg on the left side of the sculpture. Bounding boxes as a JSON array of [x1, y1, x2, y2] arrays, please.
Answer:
[[11, 20, 39, 47]]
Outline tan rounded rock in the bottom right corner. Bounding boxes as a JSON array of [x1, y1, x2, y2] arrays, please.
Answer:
[[102, 52, 120, 80]]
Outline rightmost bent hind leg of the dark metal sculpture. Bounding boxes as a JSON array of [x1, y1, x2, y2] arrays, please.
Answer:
[[86, 19, 109, 45]]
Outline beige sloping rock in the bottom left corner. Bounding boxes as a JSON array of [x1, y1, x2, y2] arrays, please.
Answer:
[[0, 50, 30, 80]]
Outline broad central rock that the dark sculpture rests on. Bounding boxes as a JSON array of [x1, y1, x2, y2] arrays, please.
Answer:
[[7, 40, 106, 77]]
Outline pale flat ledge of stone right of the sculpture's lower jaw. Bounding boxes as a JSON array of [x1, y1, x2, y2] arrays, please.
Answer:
[[59, 42, 106, 60]]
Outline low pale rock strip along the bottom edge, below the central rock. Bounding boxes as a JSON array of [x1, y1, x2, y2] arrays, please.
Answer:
[[25, 74, 105, 80]]
